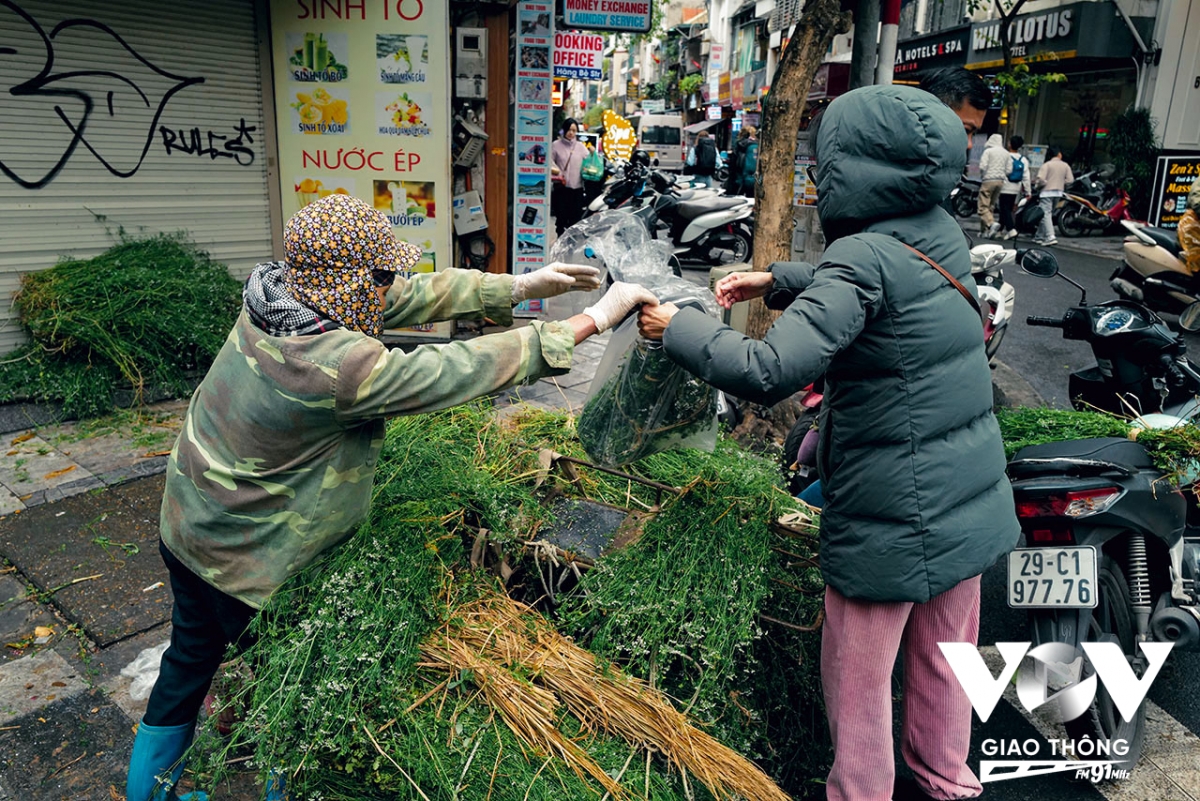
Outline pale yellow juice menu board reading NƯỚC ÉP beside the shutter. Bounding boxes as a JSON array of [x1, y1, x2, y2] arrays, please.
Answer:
[[271, 0, 454, 338]]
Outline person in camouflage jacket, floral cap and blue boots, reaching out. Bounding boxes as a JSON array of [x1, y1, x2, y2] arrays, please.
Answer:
[[126, 194, 654, 801]]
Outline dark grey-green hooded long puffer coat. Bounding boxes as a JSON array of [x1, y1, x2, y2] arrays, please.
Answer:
[[664, 86, 1019, 602]]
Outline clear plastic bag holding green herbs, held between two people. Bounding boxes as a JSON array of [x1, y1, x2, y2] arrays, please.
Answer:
[[576, 291, 719, 466]]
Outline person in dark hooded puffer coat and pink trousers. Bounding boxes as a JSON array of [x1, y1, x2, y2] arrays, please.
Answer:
[[640, 86, 1019, 801]]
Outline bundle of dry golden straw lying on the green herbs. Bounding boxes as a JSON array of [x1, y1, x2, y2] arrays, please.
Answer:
[[422, 594, 788, 801]]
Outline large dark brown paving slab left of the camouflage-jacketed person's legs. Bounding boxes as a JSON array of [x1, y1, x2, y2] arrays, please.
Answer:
[[0, 477, 172, 645]]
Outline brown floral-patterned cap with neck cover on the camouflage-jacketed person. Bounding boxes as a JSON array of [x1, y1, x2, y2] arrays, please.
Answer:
[[283, 194, 421, 337]]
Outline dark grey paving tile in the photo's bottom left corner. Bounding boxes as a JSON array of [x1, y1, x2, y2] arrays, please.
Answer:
[[0, 689, 133, 801]]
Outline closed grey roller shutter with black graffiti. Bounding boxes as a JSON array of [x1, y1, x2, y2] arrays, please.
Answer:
[[0, 0, 274, 354]]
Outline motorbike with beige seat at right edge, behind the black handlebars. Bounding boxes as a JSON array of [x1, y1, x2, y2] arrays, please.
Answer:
[[1109, 221, 1200, 314]]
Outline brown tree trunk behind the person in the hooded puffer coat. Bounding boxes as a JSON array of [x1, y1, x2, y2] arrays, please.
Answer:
[[748, 0, 850, 339]]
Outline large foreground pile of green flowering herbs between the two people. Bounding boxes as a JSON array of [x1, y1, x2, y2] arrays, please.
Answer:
[[193, 404, 829, 801]]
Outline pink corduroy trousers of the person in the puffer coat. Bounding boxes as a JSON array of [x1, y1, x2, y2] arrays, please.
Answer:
[[821, 576, 983, 801]]
